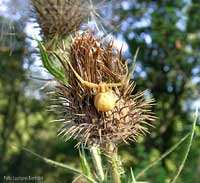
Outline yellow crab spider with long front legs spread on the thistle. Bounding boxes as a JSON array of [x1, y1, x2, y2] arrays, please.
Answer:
[[56, 49, 139, 112]]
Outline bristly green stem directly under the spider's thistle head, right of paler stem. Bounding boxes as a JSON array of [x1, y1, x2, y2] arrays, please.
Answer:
[[107, 143, 121, 183]]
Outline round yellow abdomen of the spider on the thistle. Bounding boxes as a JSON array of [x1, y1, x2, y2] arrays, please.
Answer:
[[94, 91, 117, 112]]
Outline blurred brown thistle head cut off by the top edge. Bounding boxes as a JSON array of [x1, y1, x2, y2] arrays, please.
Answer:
[[31, 0, 89, 39]]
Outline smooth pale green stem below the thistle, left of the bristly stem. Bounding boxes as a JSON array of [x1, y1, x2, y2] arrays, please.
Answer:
[[90, 145, 105, 182]]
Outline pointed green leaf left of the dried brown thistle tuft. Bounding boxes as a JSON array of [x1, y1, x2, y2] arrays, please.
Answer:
[[36, 40, 67, 84]]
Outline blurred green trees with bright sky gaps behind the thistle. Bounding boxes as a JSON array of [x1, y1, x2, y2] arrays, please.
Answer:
[[0, 0, 200, 183]]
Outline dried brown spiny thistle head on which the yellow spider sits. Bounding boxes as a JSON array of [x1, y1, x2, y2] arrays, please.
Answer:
[[53, 31, 155, 147]]
